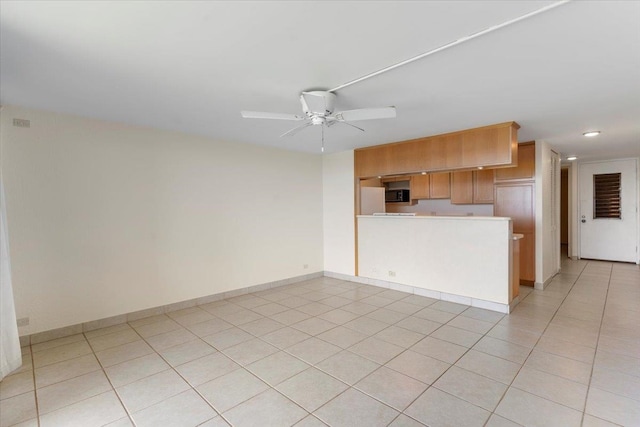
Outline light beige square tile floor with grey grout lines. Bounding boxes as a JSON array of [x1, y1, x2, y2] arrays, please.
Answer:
[[0, 260, 640, 427]]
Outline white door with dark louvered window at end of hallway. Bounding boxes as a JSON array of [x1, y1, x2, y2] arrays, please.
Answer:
[[578, 159, 638, 262]]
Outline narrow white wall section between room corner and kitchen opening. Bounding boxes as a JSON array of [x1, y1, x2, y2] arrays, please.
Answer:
[[322, 150, 355, 276]]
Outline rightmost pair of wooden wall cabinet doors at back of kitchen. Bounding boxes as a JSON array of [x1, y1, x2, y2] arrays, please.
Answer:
[[451, 169, 493, 205]]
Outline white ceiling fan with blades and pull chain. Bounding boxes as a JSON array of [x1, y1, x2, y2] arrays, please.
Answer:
[[240, 90, 396, 137]]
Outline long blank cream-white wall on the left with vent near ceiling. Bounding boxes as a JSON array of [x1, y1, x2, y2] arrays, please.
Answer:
[[0, 106, 324, 335]]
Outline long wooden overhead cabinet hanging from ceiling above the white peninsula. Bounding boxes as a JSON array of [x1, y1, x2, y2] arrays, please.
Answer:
[[354, 122, 520, 178]]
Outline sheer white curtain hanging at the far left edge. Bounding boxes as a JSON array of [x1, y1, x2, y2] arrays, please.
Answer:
[[0, 175, 22, 380]]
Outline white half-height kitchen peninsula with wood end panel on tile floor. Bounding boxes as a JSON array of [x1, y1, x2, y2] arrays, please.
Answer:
[[357, 215, 518, 313]]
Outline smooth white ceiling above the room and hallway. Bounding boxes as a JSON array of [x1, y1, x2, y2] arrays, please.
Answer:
[[0, 0, 640, 160]]
